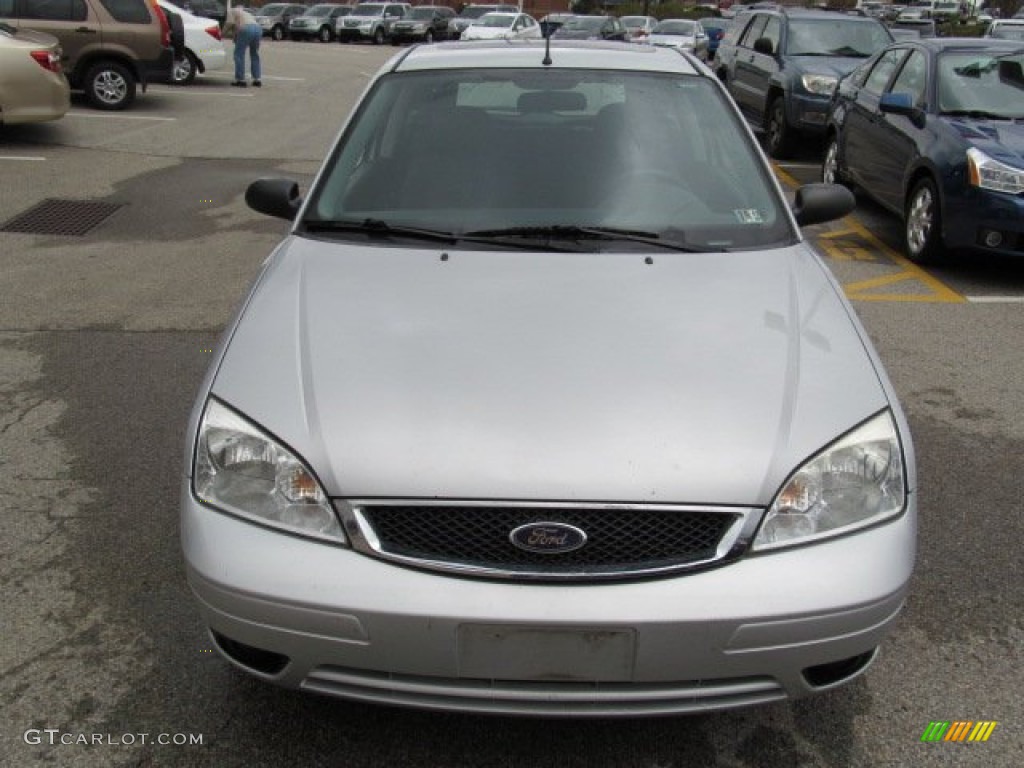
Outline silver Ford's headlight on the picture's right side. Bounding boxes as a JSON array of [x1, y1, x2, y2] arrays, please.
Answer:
[[754, 411, 906, 550]]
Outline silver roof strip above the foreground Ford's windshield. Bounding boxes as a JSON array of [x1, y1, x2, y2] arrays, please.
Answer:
[[391, 40, 703, 76]]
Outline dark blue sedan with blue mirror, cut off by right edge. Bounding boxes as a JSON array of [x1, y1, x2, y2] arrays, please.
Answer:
[[822, 38, 1024, 263]]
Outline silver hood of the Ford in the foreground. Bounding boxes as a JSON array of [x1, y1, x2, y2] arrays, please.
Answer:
[[211, 238, 888, 505]]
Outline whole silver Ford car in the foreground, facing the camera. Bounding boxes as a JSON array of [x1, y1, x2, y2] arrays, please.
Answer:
[[181, 42, 916, 716]]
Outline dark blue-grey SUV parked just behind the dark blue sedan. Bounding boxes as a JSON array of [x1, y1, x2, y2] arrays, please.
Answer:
[[715, 7, 893, 158]]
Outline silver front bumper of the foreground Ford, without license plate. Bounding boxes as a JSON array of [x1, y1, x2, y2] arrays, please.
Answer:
[[182, 480, 915, 716]]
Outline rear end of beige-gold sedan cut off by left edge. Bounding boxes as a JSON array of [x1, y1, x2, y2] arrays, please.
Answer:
[[0, 23, 71, 125]]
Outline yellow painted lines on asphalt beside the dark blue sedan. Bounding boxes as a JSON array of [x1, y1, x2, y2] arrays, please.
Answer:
[[775, 166, 967, 304]]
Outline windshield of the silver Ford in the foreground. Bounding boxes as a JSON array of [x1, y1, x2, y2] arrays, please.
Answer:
[[299, 69, 797, 250]]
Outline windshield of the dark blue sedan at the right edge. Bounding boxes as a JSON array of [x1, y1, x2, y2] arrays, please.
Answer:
[[938, 52, 1024, 119]]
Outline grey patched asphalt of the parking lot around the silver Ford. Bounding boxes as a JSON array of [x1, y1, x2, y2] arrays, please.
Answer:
[[0, 41, 1024, 768]]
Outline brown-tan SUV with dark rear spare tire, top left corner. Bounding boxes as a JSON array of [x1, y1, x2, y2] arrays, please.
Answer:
[[0, 0, 174, 110]]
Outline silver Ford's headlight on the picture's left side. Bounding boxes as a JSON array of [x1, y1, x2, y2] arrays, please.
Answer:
[[193, 399, 345, 542]]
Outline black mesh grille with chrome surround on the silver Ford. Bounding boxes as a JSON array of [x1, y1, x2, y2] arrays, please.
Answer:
[[350, 503, 748, 579]]
